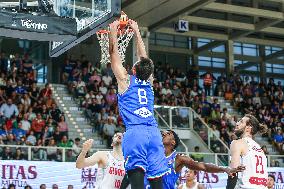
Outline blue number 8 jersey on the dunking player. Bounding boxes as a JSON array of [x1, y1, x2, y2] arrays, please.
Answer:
[[117, 75, 157, 129]]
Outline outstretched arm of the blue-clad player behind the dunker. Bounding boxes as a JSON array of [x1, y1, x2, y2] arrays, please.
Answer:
[[176, 155, 245, 175]]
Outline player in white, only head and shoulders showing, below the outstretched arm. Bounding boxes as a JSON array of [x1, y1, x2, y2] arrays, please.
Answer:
[[178, 169, 205, 189]]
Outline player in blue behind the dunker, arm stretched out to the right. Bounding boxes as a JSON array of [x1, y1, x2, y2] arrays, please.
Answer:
[[120, 130, 245, 189]]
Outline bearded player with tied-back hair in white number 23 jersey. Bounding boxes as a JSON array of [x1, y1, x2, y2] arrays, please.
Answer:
[[227, 115, 268, 189]]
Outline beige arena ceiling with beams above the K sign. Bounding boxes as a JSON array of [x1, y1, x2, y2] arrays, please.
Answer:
[[122, 0, 284, 63]]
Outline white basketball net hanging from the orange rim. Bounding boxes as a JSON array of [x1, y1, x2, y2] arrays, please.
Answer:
[[97, 26, 134, 64]]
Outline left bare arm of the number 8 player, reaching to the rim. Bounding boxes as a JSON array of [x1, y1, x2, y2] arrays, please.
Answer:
[[109, 20, 127, 83]]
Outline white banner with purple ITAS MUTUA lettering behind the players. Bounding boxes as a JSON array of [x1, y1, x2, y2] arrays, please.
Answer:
[[0, 161, 284, 189]]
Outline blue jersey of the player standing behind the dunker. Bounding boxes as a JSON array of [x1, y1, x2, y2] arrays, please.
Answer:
[[145, 151, 180, 189]]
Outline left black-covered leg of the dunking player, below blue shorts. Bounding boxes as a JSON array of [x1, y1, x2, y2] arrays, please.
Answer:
[[127, 168, 145, 189]]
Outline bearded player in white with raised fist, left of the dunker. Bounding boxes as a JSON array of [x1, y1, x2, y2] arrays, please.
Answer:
[[76, 133, 125, 189]]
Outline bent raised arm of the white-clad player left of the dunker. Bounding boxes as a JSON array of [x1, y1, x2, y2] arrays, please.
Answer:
[[76, 139, 105, 169]]
